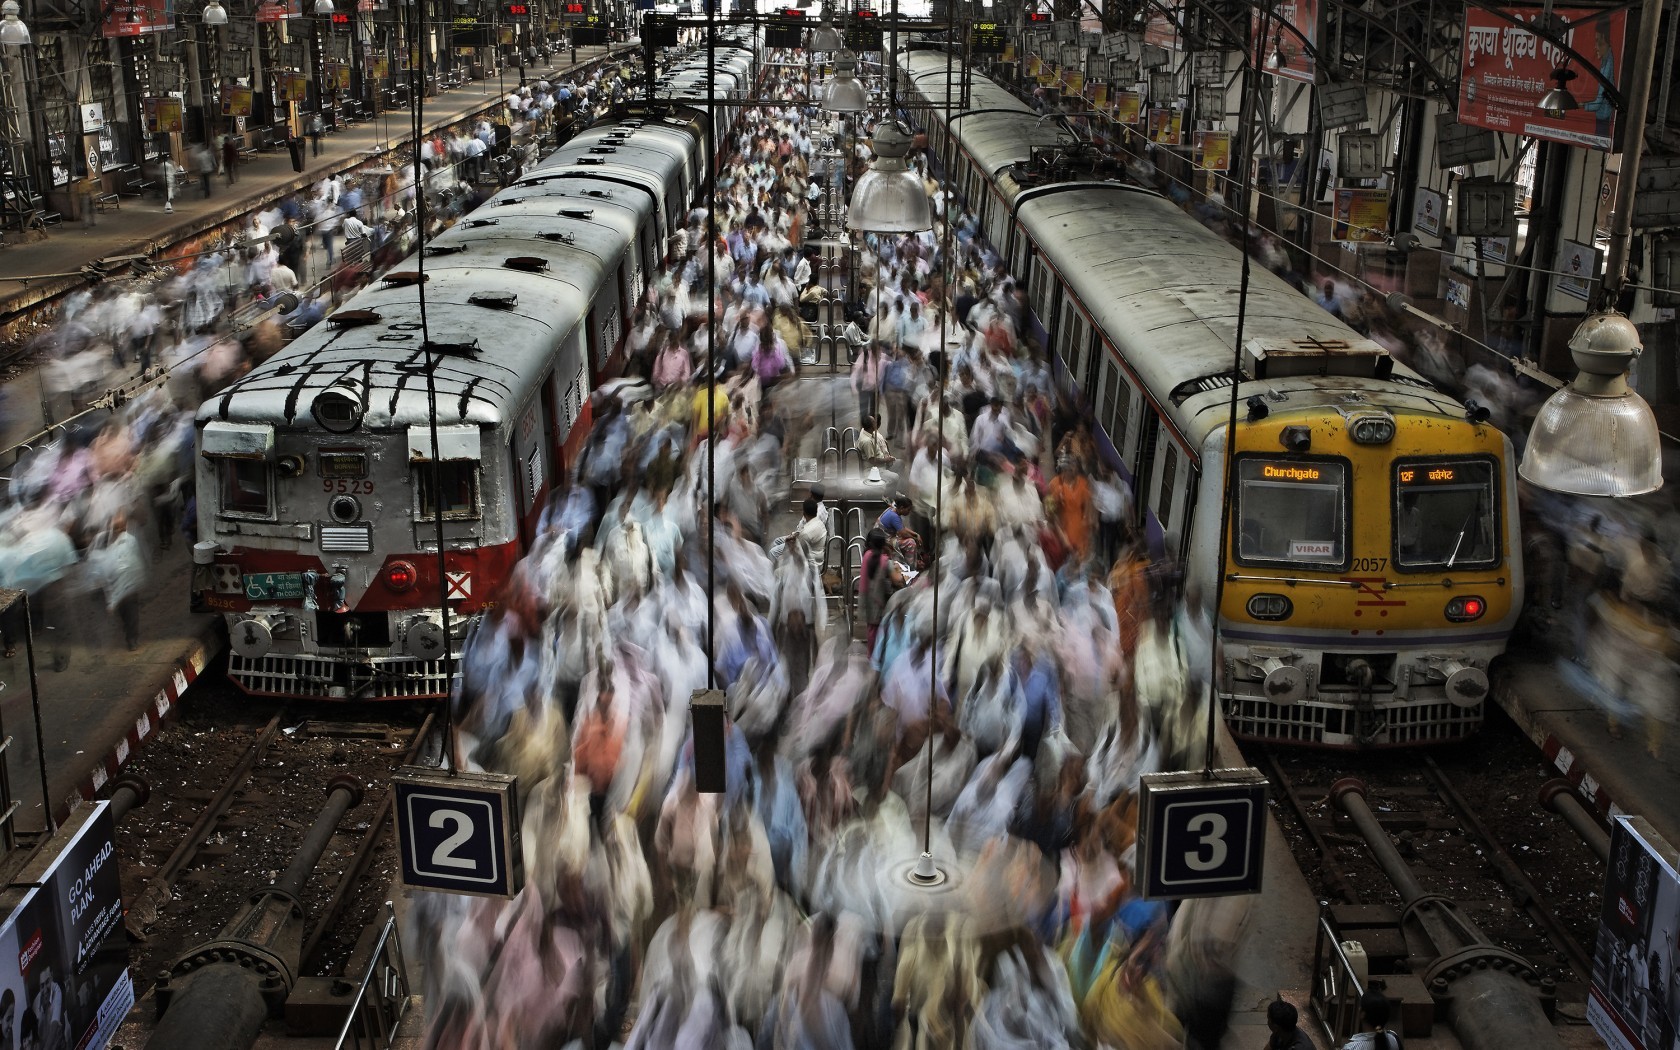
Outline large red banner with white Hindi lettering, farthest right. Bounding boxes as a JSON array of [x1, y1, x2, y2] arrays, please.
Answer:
[[1458, 7, 1626, 150]]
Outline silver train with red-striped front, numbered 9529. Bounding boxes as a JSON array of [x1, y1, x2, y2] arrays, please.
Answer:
[[192, 40, 756, 701]]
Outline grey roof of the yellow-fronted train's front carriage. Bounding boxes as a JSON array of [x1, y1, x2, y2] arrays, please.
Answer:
[[1018, 183, 1457, 447]]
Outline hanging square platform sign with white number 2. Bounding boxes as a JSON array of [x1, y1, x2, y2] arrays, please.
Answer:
[[391, 766, 524, 897]]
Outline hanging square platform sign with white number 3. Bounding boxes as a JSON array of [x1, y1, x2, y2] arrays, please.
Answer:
[[1139, 769, 1267, 899]]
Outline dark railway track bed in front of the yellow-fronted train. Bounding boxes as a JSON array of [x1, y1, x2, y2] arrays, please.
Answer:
[[1258, 705, 1603, 988]]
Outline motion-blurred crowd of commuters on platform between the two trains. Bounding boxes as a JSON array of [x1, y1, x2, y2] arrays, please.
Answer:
[[410, 57, 1240, 1050]]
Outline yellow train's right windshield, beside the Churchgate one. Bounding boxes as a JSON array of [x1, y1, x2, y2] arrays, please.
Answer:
[[1394, 459, 1499, 571]]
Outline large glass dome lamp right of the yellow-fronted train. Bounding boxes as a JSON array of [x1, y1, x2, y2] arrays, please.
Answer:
[[1517, 311, 1663, 496]]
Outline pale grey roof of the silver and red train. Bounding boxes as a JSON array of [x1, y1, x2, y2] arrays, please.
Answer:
[[198, 129, 668, 428]]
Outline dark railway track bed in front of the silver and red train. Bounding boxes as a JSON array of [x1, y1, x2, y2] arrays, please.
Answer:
[[118, 679, 433, 995]]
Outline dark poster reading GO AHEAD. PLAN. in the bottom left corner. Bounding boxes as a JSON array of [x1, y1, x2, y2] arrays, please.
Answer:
[[0, 803, 134, 1050]]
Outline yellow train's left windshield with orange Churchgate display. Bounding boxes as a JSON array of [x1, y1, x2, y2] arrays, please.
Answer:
[[1236, 457, 1347, 570]]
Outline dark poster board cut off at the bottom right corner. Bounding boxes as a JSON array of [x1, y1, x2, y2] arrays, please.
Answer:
[[1586, 816, 1680, 1050]]
